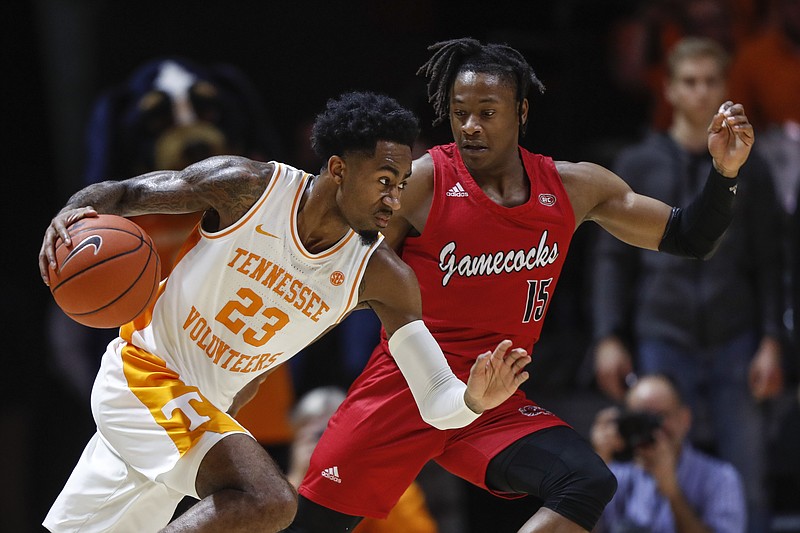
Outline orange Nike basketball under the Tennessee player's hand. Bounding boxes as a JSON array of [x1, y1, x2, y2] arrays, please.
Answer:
[[50, 215, 161, 328]]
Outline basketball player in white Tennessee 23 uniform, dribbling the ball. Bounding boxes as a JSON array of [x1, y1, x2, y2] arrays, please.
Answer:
[[39, 93, 530, 533]]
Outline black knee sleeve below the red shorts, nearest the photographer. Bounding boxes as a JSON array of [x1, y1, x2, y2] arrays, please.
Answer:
[[486, 427, 617, 531]]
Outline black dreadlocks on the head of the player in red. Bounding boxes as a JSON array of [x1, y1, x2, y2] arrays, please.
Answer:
[[417, 37, 544, 136]]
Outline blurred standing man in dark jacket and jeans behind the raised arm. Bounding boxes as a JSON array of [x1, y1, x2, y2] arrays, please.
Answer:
[[593, 38, 783, 533]]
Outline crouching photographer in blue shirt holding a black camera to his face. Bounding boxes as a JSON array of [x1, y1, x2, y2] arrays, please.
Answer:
[[591, 374, 747, 533]]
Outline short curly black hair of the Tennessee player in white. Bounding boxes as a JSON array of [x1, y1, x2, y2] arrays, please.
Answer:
[[311, 92, 419, 161]]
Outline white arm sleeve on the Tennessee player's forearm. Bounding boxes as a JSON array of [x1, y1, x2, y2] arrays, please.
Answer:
[[389, 320, 480, 429]]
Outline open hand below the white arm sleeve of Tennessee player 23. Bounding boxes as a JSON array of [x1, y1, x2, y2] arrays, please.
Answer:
[[464, 340, 531, 413]]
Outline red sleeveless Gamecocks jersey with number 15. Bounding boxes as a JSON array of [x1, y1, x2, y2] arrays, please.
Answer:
[[390, 144, 575, 365]]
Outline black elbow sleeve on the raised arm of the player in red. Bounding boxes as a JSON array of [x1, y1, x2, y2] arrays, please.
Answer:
[[658, 165, 736, 259]]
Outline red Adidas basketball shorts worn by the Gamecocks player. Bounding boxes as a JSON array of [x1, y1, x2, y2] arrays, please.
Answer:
[[300, 346, 567, 518]]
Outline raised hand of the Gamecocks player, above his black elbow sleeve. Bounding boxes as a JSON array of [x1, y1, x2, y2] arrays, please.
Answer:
[[708, 101, 755, 178]]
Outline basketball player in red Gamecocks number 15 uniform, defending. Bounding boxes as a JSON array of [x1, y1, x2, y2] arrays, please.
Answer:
[[288, 39, 754, 533]]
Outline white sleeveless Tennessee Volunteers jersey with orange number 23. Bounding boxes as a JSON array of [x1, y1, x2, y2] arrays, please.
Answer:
[[121, 163, 383, 410]]
